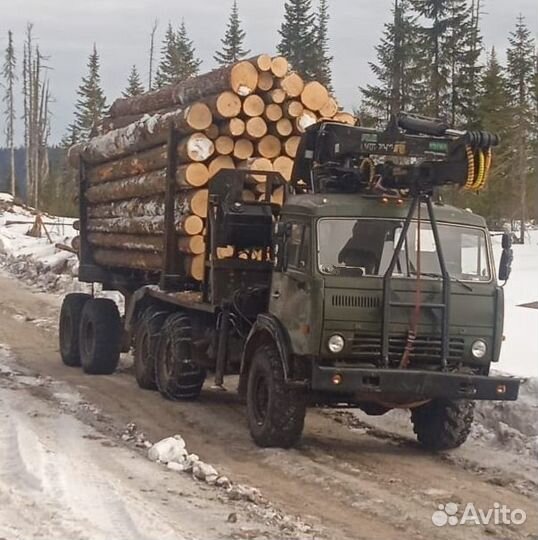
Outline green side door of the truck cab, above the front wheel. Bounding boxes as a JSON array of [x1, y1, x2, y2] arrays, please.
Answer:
[[269, 222, 312, 354]]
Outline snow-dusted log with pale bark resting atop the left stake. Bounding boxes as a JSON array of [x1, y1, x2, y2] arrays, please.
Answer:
[[69, 103, 213, 167]]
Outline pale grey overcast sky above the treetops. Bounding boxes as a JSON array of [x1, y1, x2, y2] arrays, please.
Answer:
[[0, 0, 538, 144]]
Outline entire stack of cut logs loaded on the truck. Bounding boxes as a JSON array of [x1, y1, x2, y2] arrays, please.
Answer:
[[69, 55, 356, 281]]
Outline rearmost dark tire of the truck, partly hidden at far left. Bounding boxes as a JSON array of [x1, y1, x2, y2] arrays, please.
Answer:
[[58, 293, 91, 367]]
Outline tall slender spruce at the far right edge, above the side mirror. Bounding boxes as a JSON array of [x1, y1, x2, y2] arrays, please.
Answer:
[[506, 15, 535, 242]]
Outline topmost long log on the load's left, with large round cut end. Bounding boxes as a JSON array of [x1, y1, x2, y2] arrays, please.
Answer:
[[110, 62, 258, 117]]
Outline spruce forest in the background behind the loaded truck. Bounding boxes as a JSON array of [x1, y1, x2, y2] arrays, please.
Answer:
[[0, 0, 538, 236]]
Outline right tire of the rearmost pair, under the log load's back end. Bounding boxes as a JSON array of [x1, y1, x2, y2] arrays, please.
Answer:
[[80, 298, 122, 375]]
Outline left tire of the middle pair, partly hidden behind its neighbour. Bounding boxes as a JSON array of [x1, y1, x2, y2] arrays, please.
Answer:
[[134, 306, 168, 390]]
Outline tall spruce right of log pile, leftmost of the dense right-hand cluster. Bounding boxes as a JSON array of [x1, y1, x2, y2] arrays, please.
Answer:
[[361, 0, 418, 125]]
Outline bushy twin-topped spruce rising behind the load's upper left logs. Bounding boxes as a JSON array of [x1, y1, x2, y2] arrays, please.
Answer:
[[155, 21, 202, 88]]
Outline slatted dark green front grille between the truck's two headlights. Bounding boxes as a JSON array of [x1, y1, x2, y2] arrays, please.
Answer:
[[351, 333, 465, 365]]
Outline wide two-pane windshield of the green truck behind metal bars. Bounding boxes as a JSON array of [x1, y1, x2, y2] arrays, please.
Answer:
[[318, 218, 491, 282]]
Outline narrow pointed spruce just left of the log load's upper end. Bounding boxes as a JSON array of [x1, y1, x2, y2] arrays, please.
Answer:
[[75, 45, 107, 140]]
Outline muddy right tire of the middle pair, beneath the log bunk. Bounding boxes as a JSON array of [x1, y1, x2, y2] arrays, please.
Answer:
[[155, 313, 206, 401]]
